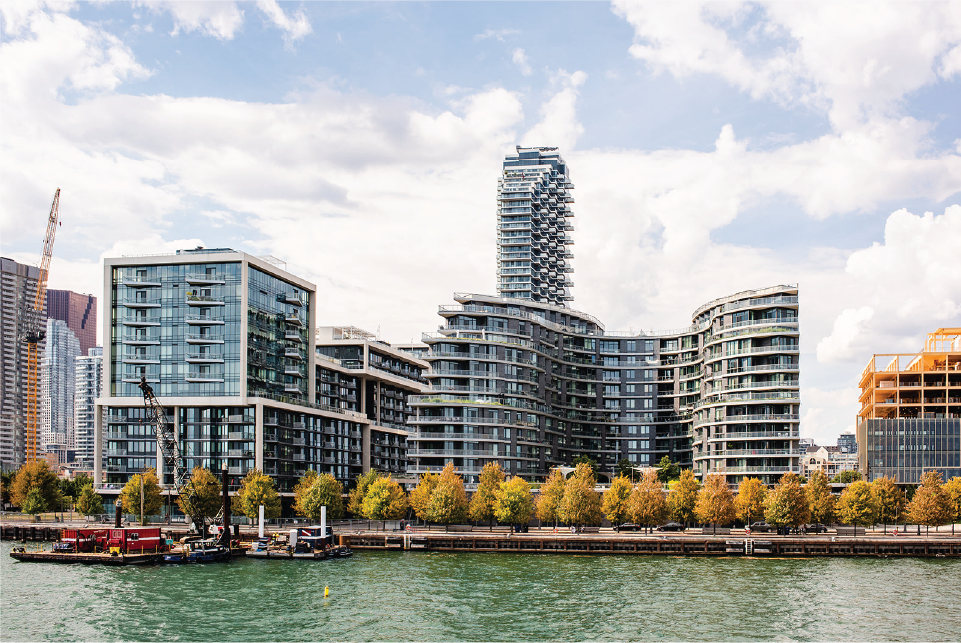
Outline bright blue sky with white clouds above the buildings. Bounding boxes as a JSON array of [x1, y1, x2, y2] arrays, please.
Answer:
[[0, 0, 961, 444]]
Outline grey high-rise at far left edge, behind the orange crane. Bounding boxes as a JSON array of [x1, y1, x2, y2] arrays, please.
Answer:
[[0, 257, 46, 470]]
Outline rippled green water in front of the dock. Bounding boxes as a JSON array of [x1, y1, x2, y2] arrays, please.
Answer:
[[0, 543, 961, 643]]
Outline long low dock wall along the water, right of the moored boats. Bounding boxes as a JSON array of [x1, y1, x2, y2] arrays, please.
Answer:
[[340, 531, 961, 558]]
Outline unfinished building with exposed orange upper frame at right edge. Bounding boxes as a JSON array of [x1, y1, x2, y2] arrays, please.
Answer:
[[856, 328, 961, 484]]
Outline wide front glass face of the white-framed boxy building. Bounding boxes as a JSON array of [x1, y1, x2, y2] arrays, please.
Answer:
[[108, 263, 242, 397]]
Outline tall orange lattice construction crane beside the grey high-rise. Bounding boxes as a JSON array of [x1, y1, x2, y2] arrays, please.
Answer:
[[22, 188, 60, 462]]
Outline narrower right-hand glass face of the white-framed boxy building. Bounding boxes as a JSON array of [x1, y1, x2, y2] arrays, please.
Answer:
[[247, 266, 310, 404]]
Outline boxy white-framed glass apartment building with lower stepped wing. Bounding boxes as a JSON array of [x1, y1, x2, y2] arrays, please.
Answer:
[[94, 248, 426, 498]]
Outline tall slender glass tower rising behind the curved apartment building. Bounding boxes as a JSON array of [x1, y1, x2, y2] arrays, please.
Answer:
[[497, 146, 574, 306]]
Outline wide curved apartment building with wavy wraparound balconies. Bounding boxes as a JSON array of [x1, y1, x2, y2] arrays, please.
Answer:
[[408, 286, 800, 484]]
